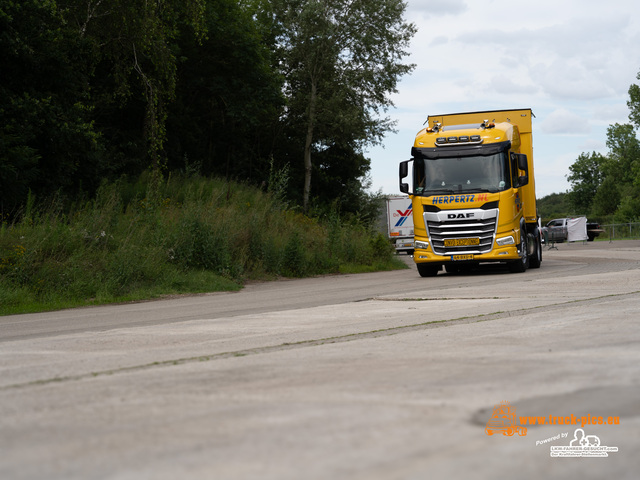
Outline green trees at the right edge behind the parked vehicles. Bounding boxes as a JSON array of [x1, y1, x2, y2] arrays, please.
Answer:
[[567, 73, 640, 223]]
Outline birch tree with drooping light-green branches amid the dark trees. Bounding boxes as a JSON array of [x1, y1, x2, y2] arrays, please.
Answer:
[[63, 0, 205, 170]]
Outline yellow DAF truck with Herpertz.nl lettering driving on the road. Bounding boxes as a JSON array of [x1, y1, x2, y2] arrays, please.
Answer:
[[400, 109, 542, 277]]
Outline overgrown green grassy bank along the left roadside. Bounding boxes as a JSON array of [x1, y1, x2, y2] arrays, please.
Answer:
[[0, 175, 399, 314]]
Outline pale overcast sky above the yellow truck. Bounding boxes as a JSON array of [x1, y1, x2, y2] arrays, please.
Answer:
[[368, 0, 640, 198]]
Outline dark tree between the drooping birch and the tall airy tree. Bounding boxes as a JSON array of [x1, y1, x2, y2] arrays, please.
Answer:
[[167, 0, 284, 181]]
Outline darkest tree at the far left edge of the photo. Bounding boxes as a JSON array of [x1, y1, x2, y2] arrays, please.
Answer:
[[0, 0, 97, 211]]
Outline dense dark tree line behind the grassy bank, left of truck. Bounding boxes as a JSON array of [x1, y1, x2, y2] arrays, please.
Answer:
[[0, 0, 415, 218]]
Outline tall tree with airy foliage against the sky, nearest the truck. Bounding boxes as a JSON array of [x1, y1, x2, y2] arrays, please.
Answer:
[[263, 0, 416, 210]]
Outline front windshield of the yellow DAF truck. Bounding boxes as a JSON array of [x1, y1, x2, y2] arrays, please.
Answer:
[[414, 152, 511, 195]]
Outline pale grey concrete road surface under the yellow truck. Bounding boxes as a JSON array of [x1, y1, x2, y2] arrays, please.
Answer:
[[0, 241, 640, 480]]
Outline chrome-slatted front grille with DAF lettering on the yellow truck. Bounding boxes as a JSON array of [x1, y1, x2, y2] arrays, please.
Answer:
[[424, 209, 499, 255]]
